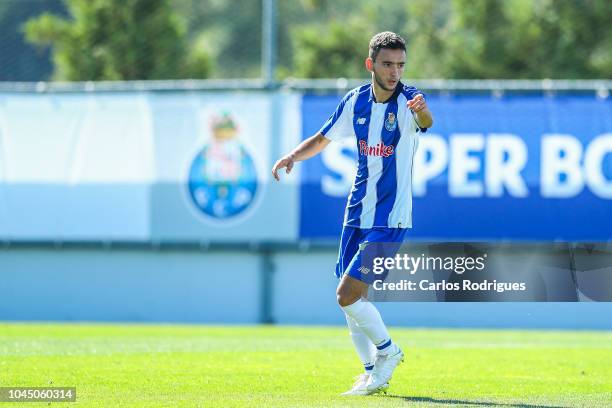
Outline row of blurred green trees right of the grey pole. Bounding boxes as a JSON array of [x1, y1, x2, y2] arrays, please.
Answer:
[[279, 0, 612, 79]]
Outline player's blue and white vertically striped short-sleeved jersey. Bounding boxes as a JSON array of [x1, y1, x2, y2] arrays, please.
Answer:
[[320, 83, 426, 228]]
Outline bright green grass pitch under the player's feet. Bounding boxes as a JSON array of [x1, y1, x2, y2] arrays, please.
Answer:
[[0, 323, 612, 408]]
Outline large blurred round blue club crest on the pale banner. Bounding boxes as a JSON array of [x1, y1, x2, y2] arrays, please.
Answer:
[[189, 113, 259, 221]]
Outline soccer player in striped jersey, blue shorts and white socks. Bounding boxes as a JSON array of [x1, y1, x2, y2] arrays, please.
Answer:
[[272, 32, 433, 395]]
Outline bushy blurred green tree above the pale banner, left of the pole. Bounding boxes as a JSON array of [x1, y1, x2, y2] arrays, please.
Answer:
[[25, 0, 211, 81]]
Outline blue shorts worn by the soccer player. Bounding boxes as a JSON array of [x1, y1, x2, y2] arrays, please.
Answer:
[[336, 226, 408, 284]]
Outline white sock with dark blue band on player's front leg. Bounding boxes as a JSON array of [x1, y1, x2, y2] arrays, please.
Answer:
[[342, 299, 397, 354]]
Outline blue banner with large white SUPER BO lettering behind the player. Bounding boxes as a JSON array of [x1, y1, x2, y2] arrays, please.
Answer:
[[300, 94, 612, 241]]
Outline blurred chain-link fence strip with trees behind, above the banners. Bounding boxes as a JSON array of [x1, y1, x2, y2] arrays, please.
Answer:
[[0, 0, 612, 81]]
